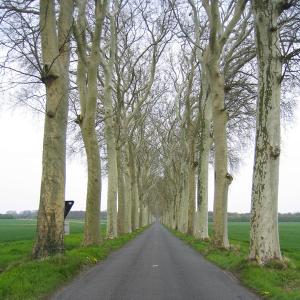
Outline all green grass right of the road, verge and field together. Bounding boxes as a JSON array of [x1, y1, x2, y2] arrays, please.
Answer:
[[171, 222, 300, 300]]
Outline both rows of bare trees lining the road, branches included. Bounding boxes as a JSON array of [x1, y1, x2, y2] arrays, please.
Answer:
[[0, 0, 300, 263]]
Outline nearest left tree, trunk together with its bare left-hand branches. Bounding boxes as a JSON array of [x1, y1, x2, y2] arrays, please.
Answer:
[[0, 0, 73, 258]]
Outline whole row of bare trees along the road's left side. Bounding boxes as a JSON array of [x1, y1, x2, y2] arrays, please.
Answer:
[[0, 0, 164, 258]]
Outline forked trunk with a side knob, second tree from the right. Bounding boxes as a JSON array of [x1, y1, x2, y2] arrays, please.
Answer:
[[202, 0, 246, 248]]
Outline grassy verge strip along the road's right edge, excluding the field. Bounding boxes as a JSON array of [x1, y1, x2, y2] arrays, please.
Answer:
[[170, 230, 300, 300]]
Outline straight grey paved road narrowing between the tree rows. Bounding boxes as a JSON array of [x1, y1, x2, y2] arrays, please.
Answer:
[[52, 223, 259, 300]]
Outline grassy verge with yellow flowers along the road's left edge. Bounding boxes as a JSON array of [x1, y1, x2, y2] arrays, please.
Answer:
[[0, 229, 143, 300]]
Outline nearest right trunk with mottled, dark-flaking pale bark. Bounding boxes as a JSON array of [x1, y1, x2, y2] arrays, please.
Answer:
[[249, 0, 282, 264]]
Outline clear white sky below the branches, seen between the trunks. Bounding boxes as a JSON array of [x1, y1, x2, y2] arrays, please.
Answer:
[[0, 104, 300, 213]]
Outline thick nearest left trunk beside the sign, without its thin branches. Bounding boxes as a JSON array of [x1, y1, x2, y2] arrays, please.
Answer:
[[33, 0, 73, 258]]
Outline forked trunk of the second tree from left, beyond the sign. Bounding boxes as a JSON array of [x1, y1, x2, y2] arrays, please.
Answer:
[[74, 0, 108, 246]]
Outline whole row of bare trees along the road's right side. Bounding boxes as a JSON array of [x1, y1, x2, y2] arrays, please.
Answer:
[[160, 0, 299, 264]]
